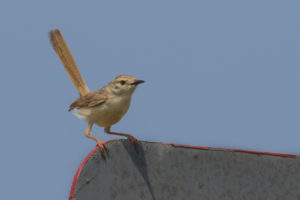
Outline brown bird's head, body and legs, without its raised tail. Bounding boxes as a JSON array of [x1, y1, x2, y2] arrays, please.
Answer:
[[69, 75, 145, 153]]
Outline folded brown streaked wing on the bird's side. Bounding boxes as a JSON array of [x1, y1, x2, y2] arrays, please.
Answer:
[[69, 88, 107, 111]]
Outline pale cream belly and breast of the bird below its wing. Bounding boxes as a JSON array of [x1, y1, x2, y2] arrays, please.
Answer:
[[74, 96, 130, 127]]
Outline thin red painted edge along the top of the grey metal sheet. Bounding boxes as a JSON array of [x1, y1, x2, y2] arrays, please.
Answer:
[[69, 139, 297, 200]]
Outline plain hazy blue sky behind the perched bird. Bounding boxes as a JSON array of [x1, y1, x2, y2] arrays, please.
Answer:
[[0, 0, 300, 200]]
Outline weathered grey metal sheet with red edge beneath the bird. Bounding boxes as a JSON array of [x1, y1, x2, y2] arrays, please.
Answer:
[[70, 140, 300, 200]]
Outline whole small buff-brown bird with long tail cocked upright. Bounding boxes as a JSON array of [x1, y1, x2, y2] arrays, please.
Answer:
[[49, 29, 145, 157]]
